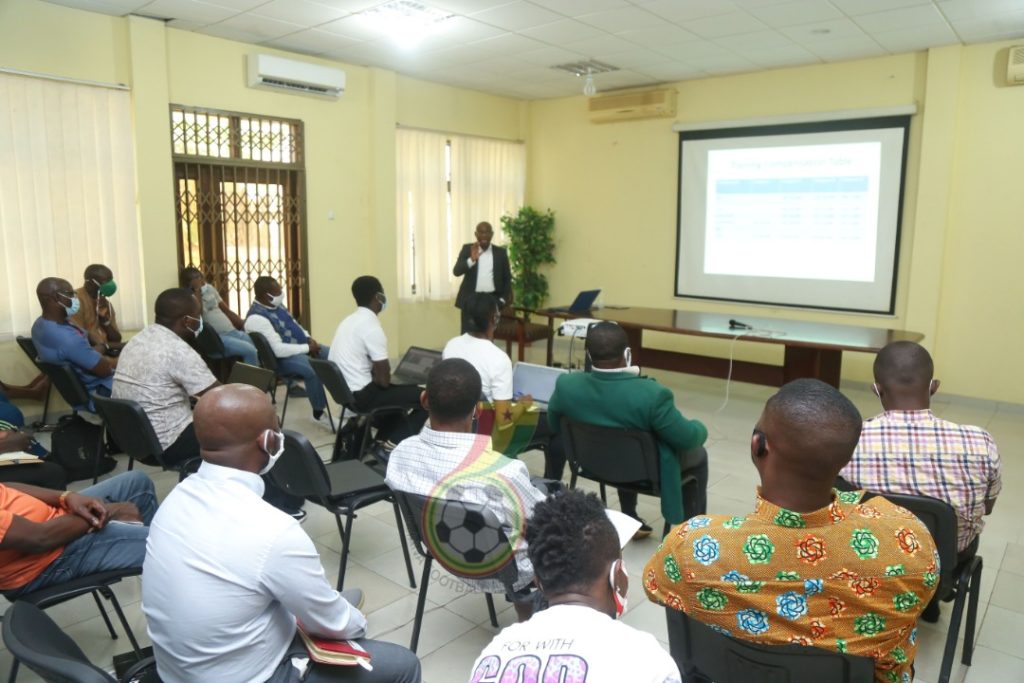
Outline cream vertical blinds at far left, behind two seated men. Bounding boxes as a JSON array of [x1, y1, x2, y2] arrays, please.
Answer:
[[0, 74, 144, 340]]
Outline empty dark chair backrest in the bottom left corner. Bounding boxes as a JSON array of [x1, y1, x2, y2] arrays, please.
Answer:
[[3, 601, 115, 683]]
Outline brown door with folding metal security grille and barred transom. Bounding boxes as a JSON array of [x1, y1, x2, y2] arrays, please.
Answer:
[[171, 106, 309, 327]]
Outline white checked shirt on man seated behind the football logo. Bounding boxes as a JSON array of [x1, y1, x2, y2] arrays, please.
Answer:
[[385, 427, 545, 593]]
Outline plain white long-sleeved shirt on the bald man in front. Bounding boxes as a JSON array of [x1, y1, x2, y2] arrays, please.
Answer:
[[142, 462, 367, 683]]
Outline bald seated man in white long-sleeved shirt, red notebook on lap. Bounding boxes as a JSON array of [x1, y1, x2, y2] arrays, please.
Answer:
[[142, 384, 420, 683]]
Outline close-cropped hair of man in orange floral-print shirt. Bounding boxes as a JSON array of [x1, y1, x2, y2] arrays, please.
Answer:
[[764, 379, 863, 476]]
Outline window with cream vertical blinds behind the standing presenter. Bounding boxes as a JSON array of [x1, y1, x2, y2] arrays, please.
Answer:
[[395, 128, 526, 301]]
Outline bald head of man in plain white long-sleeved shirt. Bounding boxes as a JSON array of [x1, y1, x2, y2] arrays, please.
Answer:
[[193, 384, 279, 472]]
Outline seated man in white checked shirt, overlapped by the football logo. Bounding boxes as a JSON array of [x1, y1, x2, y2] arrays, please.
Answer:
[[385, 358, 545, 621]]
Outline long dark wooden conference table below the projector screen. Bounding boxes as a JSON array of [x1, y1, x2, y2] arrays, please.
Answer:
[[532, 306, 925, 388]]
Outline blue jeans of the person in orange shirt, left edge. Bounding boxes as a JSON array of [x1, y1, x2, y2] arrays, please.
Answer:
[[5, 470, 157, 600]]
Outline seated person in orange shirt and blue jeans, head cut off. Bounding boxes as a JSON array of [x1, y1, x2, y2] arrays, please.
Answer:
[[0, 470, 157, 600]]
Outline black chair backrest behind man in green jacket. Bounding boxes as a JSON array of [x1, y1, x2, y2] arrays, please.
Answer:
[[562, 418, 662, 495]]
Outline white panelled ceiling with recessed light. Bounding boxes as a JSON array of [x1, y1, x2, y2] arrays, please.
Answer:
[[41, 0, 1024, 99]]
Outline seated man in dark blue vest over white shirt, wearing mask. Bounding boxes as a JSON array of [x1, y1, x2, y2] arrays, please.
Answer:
[[245, 275, 331, 428]]
